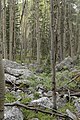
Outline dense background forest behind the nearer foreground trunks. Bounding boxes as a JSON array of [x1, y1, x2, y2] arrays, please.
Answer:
[[2, 0, 80, 64]]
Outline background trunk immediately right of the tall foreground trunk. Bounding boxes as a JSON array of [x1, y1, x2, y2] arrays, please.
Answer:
[[58, 0, 64, 62]]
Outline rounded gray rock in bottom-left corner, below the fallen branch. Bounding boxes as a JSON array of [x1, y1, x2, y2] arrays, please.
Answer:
[[4, 107, 23, 120]]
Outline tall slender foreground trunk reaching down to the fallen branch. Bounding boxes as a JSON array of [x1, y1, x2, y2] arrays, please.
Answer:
[[50, 0, 57, 109]]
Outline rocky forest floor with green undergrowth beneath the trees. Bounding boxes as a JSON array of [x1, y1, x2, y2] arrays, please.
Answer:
[[5, 57, 80, 120]]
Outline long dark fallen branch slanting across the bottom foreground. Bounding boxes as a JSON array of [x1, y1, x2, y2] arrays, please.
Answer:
[[4, 102, 73, 120]]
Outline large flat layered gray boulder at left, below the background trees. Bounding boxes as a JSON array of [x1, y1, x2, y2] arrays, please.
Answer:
[[3, 59, 34, 79]]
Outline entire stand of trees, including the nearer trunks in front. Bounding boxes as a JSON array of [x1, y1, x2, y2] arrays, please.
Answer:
[[0, 0, 80, 120]]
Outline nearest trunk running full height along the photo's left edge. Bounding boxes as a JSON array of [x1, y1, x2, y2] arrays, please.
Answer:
[[0, 0, 4, 120]]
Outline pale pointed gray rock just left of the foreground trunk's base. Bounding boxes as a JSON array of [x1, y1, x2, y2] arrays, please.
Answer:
[[30, 97, 52, 108]]
